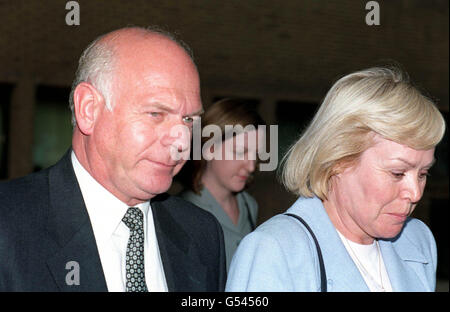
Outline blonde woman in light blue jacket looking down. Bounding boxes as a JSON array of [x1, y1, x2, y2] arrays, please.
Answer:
[[226, 68, 445, 291]]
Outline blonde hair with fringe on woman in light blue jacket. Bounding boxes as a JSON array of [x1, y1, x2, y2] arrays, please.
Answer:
[[281, 67, 445, 200]]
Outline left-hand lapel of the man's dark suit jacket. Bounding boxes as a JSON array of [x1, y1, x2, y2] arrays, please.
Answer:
[[47, 150, 107, 291]]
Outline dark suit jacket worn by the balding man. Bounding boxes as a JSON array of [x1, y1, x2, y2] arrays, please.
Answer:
[[0, 150, 226, 291]]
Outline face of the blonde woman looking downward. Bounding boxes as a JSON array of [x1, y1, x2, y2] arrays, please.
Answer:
[[325, 136, 434, 244]]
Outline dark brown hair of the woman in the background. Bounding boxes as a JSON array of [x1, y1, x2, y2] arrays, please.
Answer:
[[180, 98, 266, 194]]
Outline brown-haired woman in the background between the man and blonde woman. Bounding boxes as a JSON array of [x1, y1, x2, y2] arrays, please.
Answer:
[[180, 99, 265, 268]]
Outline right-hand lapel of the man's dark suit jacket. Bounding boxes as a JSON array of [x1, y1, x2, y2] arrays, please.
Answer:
[[151, 195, 207, 291]]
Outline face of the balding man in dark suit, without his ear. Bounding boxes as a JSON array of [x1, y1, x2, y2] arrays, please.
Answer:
[[91, 38, 202, 204]]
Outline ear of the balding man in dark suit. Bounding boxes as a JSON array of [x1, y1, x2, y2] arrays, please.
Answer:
[[73, 82, 105, 135]]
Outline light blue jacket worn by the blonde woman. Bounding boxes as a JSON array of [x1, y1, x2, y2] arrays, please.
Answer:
[[226, 198, 437, 292]]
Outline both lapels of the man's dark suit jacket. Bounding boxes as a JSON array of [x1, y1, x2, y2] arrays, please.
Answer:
[[47, 149, 207, 292]]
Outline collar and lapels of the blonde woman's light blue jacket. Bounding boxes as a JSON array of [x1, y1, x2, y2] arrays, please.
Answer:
[[288, 197, 427, 291]]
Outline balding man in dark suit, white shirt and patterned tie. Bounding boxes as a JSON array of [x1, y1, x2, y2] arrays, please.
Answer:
[[0, 28, 226, 292]]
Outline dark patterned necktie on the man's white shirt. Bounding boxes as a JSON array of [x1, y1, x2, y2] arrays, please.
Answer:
[[122, 207, 148, 292]]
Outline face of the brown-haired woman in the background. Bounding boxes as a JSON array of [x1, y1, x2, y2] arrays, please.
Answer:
[[205, 130, 258, 193]]
